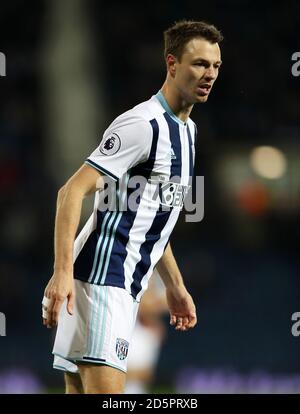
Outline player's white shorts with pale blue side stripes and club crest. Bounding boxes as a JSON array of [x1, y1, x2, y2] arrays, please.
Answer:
[[53, 279, 139, 373]]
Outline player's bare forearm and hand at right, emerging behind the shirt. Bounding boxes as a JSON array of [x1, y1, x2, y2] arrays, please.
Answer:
[[157, 243, 197, 331]]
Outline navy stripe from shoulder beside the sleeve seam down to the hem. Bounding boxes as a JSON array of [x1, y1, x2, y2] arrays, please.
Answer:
[[104, 119, 159, 288]]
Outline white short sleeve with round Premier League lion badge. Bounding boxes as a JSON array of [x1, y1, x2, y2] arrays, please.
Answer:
[[85, 116, 153, 180]]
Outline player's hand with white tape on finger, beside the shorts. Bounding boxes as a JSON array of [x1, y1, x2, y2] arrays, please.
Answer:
[[42, 272, 75, 328]]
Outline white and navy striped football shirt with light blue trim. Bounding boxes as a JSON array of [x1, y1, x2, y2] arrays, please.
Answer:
[[74, 92, 196, 300]]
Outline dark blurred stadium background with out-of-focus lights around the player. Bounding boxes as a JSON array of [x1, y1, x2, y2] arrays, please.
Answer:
[[0, 0, 300, 393]]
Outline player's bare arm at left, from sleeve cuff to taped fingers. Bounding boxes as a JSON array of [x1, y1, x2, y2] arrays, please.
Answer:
[[43, 165, 103, 328]]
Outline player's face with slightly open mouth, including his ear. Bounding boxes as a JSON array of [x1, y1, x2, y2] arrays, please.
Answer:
[[168, 38, 222, 104]]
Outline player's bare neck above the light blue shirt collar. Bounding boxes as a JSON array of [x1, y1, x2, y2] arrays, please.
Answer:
[[161, 76, 193, 122]]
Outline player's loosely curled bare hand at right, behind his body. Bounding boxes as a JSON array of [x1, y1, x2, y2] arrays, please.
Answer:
[[166, 286, 197, 331]]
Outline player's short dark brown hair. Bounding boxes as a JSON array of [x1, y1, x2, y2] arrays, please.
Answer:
[[164, 20, 223, 61]]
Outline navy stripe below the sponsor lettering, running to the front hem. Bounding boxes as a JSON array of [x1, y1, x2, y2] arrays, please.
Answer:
[[131, 209, 172, 298]]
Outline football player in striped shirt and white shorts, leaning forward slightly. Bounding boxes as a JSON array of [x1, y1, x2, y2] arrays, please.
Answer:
[[42, 21, 222, 394]]
